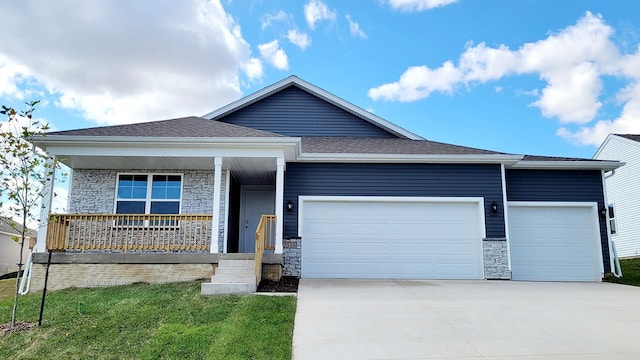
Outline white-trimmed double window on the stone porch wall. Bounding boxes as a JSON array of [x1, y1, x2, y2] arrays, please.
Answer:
[[115, 174, 182, 214]]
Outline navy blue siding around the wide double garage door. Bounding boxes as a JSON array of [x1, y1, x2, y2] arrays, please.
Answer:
[[284, 163, 505, 238]]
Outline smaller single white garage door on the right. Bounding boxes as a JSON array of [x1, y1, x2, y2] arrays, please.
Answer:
[[509, 202, 602, 281]]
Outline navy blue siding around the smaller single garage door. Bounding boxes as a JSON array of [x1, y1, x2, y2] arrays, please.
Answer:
[[506, 170, 611, 272]]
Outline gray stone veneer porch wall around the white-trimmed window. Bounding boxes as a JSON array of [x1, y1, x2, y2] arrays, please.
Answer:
[[69, 169, 227, 252]]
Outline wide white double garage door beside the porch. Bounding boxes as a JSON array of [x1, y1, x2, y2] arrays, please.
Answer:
[[300, 197, 484, 279]]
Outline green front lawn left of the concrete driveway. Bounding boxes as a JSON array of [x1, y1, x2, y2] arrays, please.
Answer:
[[0, 282, 296, 359]]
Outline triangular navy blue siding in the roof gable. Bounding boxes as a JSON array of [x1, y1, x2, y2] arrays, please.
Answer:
[[219, 86, 397, 138]]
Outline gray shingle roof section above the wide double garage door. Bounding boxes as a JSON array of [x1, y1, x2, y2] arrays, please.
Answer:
[[302, 136, 504, 155]]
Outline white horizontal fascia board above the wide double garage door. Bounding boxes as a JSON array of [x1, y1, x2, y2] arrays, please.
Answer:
[[297, 153, 522, 165]]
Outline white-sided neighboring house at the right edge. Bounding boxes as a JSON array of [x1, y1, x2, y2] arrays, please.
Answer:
[[593, 134, 640, 257]]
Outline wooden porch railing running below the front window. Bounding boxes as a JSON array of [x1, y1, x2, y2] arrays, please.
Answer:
[[47, 214, 213, 251]]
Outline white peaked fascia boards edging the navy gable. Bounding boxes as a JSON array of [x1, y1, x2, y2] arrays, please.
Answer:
[[202, 75, 425, 140]]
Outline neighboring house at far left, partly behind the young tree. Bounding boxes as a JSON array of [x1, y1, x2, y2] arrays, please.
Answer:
[[0, 216, 37, 275]]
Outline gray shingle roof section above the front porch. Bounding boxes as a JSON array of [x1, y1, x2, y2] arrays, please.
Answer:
[[47, 116, 282, 137]]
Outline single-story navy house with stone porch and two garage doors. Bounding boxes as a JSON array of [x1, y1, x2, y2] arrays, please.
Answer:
[[26, 76, 621, 289]]
